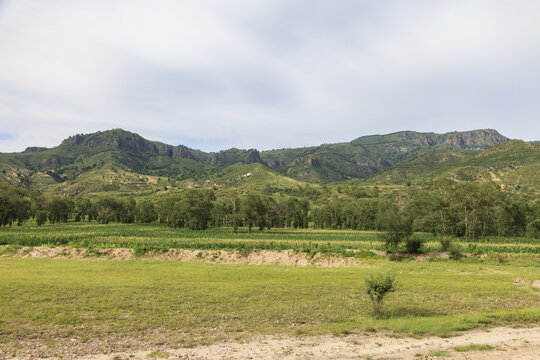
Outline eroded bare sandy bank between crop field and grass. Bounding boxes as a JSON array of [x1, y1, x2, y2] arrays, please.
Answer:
[[0, 245, 456, 268]]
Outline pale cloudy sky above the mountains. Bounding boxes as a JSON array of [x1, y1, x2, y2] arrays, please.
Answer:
[[0, 0, 540, 152]]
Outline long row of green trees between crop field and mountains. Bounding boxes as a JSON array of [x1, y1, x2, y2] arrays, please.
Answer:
[[0, 180, 540, 239]]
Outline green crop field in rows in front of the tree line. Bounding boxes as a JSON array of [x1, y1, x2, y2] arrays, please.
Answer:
[[0, 223, 540, 254]]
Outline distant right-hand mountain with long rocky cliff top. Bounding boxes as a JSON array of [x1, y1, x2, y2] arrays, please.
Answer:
[[261, 129, 509, 183]]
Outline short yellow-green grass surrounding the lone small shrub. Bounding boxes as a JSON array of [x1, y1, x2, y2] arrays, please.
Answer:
[[0, 258, 540, 356]]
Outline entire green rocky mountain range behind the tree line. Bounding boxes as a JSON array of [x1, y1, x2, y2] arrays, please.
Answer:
[[0, 129, 540, 195]]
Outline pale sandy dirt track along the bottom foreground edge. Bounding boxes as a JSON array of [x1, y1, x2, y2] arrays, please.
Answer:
[[25, 327, 540, 360]]
